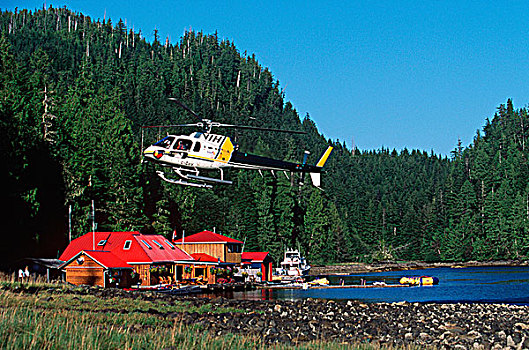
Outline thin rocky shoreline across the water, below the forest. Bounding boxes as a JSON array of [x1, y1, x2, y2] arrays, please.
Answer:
[[310, 260, 529, 276]]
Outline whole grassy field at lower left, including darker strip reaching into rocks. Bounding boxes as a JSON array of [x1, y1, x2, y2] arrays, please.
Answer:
[[0, 275, 412, 350]]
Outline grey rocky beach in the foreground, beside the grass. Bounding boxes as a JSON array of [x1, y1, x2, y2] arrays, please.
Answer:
[[14, 288, 529, 349]]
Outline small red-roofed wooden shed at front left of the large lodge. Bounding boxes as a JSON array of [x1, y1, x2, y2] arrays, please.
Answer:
[[61, 250, 134, 288]]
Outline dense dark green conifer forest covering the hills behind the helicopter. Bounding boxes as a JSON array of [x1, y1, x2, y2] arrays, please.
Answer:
[[0, 7, 529, 264]]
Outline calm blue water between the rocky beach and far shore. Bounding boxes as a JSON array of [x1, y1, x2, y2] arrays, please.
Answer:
[[213, 267, 529, 305]]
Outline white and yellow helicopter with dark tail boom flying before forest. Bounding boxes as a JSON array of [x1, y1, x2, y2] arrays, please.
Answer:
[[142, 98, 333, 189]]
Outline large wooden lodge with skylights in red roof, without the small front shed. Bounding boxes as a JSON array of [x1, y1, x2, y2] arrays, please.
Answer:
[[59, 232, 194, 286]]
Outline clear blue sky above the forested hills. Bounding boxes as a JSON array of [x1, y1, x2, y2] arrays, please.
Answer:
[[4, 0, 529, 155]]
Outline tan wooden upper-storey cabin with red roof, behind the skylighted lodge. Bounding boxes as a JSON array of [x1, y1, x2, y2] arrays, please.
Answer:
[[173, 231, 243, 265]]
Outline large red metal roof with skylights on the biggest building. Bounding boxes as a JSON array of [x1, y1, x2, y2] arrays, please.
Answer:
[[59, 231, 193, 264]]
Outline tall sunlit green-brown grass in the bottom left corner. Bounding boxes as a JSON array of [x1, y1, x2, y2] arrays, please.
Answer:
[[0, 292, 262, 349]]
